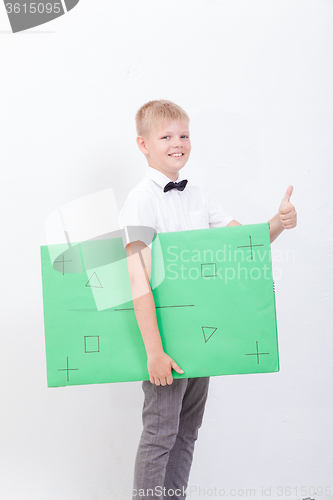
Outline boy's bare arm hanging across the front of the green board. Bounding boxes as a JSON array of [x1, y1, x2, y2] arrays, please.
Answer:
[[126, 241, 184, 385]]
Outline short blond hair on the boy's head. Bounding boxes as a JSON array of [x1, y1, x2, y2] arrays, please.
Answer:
[[135, 99, 190, 137]]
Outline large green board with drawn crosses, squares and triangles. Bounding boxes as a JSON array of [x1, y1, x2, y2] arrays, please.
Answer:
[[41, 223, 279, 387]]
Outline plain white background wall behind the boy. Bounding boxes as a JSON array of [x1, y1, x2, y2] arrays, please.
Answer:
[[0, 0, 333, 500]]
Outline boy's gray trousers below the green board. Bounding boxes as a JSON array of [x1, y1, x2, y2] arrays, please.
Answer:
[[133, 377, 209, 500]]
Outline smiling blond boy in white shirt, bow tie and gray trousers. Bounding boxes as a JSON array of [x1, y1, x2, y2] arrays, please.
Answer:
[[120, 100, 296, 500]]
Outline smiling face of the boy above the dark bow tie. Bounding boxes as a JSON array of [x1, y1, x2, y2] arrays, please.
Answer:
[[137, 120, 191, 181]]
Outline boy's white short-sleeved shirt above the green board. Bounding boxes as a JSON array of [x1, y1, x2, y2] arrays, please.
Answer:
[[119, 167, 233, 243]]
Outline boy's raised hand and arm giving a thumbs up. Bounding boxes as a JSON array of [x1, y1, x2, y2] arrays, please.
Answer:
[[227, 186, 297, 243]]
